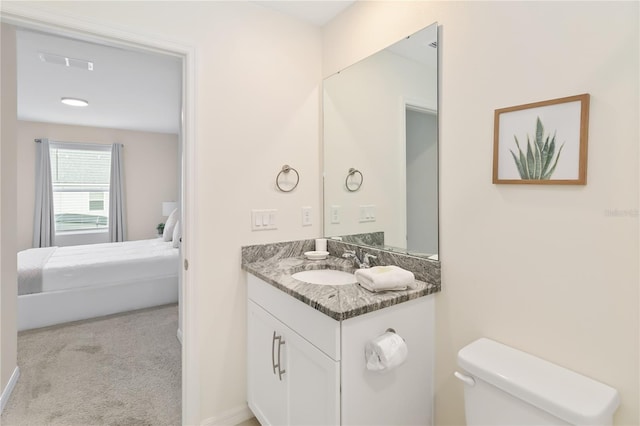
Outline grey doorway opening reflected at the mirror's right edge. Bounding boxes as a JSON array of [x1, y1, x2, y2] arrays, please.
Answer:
[[405, 105, 438, 255]]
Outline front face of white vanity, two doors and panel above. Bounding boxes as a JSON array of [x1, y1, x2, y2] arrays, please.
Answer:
[[247, 276, 340, 426]]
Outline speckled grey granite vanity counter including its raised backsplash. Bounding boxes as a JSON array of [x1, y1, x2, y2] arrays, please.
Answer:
[[242, 240, 440, 321]]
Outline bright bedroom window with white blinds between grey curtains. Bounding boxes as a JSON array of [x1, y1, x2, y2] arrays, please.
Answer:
[[50, 143, 111, 233]]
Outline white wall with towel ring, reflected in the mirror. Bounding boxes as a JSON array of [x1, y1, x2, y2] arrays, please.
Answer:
[[323, 51, 437, 248]]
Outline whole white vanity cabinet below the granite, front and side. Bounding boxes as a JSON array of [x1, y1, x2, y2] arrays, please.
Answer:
[[247, 274, 434, 426]]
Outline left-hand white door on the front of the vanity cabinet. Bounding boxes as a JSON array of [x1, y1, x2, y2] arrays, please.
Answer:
[[247, 301, 289, 425]]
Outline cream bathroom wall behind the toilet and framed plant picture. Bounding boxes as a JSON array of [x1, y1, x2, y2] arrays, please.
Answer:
[[323, 2, 640, 425]]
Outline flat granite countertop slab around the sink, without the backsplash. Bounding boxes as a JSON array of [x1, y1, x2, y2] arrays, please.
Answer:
[[242, 256, 440, 321]]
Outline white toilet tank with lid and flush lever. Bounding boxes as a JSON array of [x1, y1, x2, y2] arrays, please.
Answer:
[[455, 338, 620, 426]]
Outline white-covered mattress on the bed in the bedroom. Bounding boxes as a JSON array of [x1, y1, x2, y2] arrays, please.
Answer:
[[18, 238, 179, 294]]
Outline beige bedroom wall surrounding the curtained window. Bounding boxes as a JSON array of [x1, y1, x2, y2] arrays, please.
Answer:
[[17, 120, 180, 250]]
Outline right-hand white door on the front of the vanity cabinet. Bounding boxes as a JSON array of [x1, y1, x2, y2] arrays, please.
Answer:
[[285, 331, 340, 426]]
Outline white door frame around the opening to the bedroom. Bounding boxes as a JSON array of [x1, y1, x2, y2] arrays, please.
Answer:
[[0, 2, 200, 424]]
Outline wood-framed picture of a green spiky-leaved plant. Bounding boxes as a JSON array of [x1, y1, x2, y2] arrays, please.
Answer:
[[493, 93, 589, 185]]
